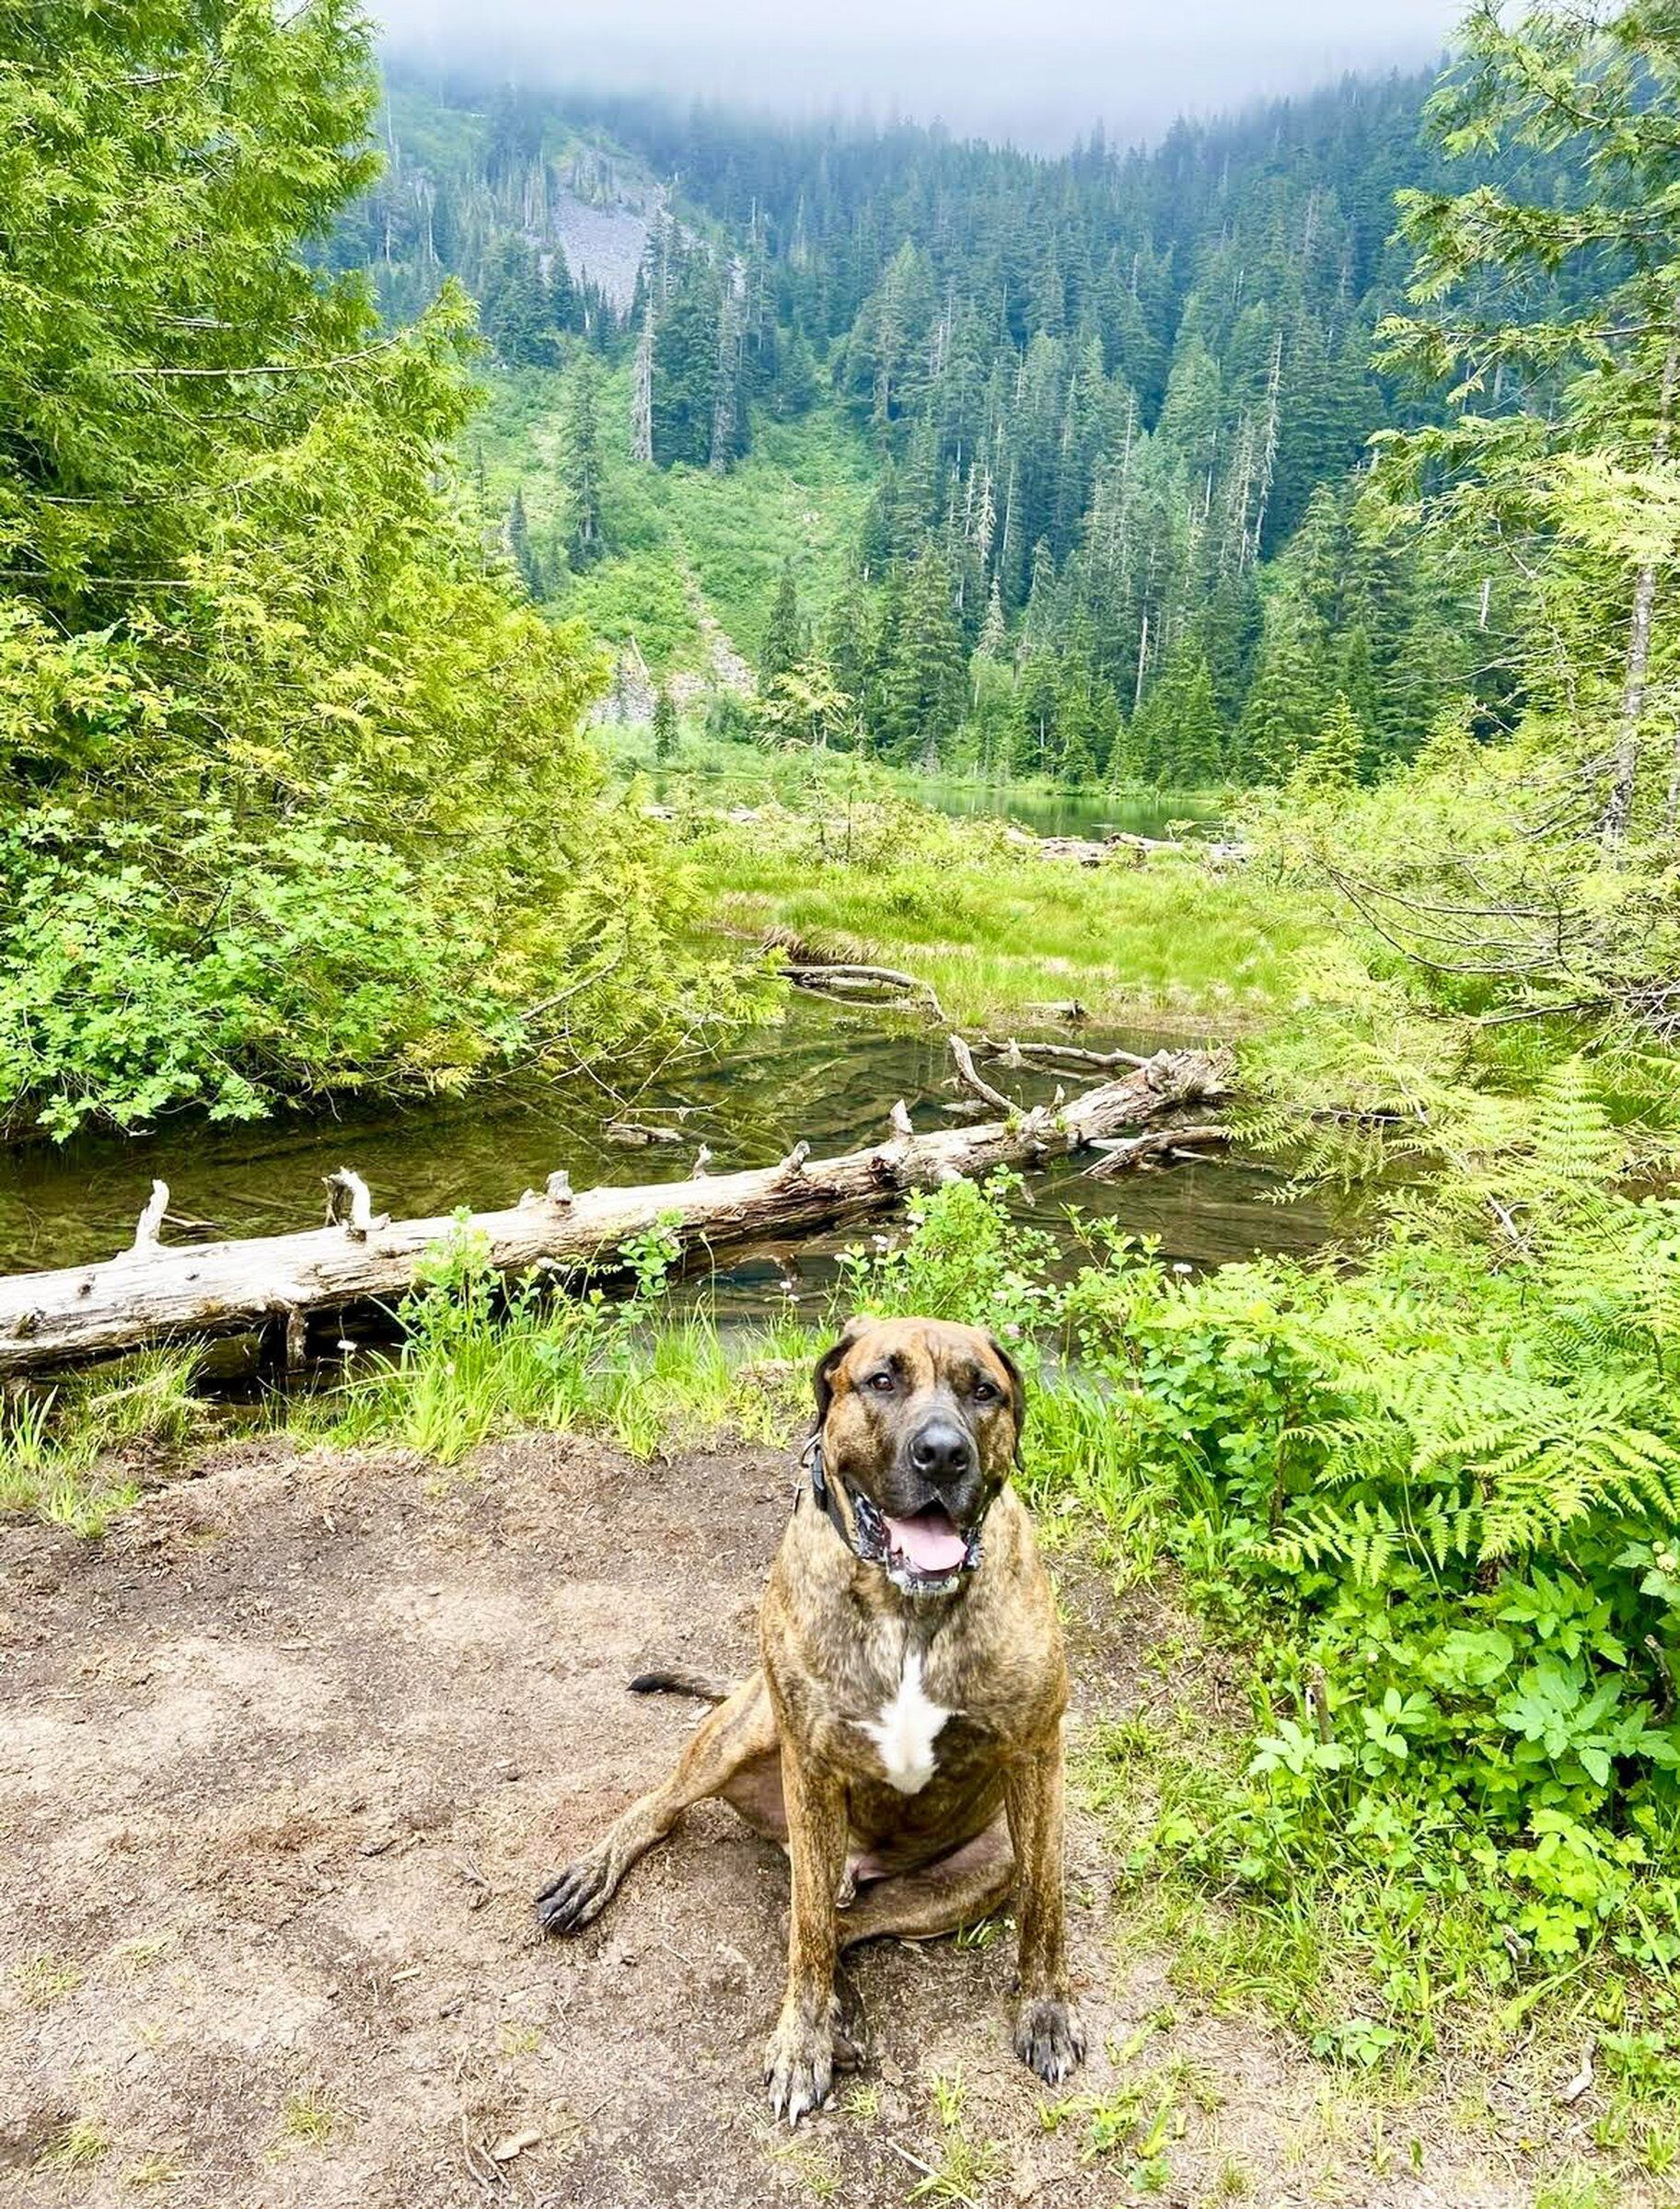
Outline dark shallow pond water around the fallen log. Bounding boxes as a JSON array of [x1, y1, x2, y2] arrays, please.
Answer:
[[0, 992, 1335, 1314]]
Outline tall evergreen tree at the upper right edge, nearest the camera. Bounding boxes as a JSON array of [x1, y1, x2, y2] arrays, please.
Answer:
[[1384, 0, 1680, 860]]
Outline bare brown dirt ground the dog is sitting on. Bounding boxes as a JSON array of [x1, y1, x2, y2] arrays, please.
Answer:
[[0, 1438, 1582, 2209]]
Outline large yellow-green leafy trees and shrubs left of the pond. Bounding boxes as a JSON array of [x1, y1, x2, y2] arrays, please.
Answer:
[[0, 0, 732, 1136]]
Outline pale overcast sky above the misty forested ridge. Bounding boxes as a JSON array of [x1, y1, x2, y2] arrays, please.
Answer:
[[371, 0, 1461, 145]]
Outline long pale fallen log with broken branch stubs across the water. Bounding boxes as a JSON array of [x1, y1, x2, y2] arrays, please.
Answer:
[[0, 1051, 1232, 1379]]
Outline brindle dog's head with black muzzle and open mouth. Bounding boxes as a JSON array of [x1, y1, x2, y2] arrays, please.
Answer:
[[816, 1319, 1025, 1595]]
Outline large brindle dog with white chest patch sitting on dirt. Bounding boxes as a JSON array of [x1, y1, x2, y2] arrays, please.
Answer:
[[538, 1319, 1085, 2125]]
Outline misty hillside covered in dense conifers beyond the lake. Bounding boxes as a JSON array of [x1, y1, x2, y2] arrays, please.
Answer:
[[336, 77, 1573, 786]]
